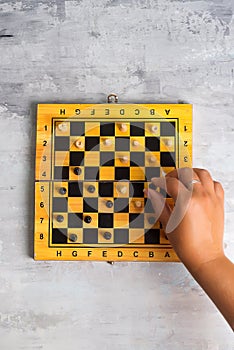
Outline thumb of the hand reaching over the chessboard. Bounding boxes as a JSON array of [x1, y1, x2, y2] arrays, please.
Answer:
[[145, 188, 171, 228]]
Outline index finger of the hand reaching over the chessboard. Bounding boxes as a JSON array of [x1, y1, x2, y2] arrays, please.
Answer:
[[151, 176, 187, 200]]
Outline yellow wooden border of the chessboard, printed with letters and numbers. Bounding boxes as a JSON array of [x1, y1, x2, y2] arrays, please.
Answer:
[[34, 103, 192, 262]]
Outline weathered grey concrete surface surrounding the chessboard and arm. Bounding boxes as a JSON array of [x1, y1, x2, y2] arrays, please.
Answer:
[[0, 0, 234, 350]]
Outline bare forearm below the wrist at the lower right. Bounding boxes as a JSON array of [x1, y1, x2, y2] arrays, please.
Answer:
[[190, 256, 234, 331]]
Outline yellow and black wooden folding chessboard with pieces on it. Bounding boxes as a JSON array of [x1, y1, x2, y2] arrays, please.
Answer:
[[34, 103, 192, 261]]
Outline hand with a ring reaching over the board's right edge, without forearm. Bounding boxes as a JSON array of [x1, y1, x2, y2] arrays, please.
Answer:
[[146, 168, 224, 271]]
